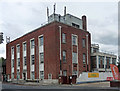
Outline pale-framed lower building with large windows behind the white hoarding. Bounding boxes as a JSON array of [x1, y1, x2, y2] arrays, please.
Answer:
[[91, 44, 117, 72]]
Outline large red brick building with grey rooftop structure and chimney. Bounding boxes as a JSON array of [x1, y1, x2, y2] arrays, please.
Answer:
[[6, 14, 91, 83]]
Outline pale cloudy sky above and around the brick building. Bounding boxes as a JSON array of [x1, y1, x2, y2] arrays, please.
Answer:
[[0, 0, 118, 58]]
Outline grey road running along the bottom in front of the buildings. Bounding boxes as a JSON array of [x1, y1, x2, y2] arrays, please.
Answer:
[[2, 83, 120, 91]]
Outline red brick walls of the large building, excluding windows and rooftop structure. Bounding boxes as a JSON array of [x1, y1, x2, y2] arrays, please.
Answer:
[[6, 21, 91, 83]]
